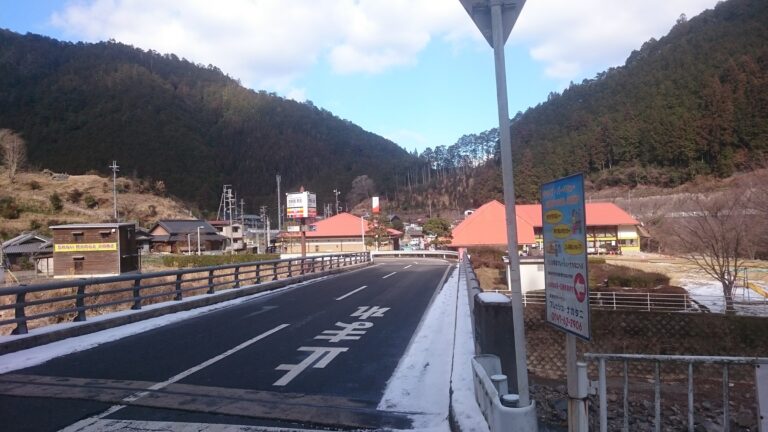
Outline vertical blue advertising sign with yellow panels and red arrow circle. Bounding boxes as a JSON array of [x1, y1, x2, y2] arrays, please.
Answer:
[[541, 174, 591, 340]]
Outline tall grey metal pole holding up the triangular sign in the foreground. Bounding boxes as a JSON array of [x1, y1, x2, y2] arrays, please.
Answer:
[[491, 0, 531, 407]]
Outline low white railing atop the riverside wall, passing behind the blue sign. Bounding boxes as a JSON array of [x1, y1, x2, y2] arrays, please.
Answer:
[[491, 290, 768, 314]]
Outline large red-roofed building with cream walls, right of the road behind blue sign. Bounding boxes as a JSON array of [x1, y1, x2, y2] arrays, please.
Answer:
[[450, 200, 640, 253]]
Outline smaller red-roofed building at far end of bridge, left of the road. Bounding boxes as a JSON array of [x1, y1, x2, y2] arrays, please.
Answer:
[[280, 213, 403, 254]]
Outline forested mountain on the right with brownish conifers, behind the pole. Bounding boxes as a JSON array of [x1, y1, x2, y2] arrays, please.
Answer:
[[400, 0, 768, 208]]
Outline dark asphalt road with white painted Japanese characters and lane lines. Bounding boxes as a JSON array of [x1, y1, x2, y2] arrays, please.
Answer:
[[0, 258, 450, 431]]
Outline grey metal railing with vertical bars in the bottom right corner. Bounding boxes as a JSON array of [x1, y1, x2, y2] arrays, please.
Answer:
[[584, 353, 768, 432]]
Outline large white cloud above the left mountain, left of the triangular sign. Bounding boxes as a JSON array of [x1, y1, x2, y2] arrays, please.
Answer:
[[51, 0, 471, 91]]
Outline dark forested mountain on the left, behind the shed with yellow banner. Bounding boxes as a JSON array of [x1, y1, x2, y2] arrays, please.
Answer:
[[0, 29, 416, 214]]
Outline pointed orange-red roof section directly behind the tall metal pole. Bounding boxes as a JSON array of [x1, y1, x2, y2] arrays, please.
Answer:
[[450, 200, 536, 247]]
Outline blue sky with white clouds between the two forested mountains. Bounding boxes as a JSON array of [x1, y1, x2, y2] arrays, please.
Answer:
[[0, 0, 717, 152]]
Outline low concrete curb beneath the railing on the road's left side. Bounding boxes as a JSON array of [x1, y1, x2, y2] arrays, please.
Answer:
[[0, 261, 372, 355]]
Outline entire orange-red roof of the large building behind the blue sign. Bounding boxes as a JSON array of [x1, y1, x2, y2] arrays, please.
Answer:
[[451, 200, 640, 247]]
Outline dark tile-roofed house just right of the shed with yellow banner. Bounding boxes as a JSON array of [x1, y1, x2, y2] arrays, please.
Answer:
[[149, 219, 227, 254]]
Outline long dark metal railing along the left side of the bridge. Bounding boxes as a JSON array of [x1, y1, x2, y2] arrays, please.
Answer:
[[0, 252, 370, 335]]
